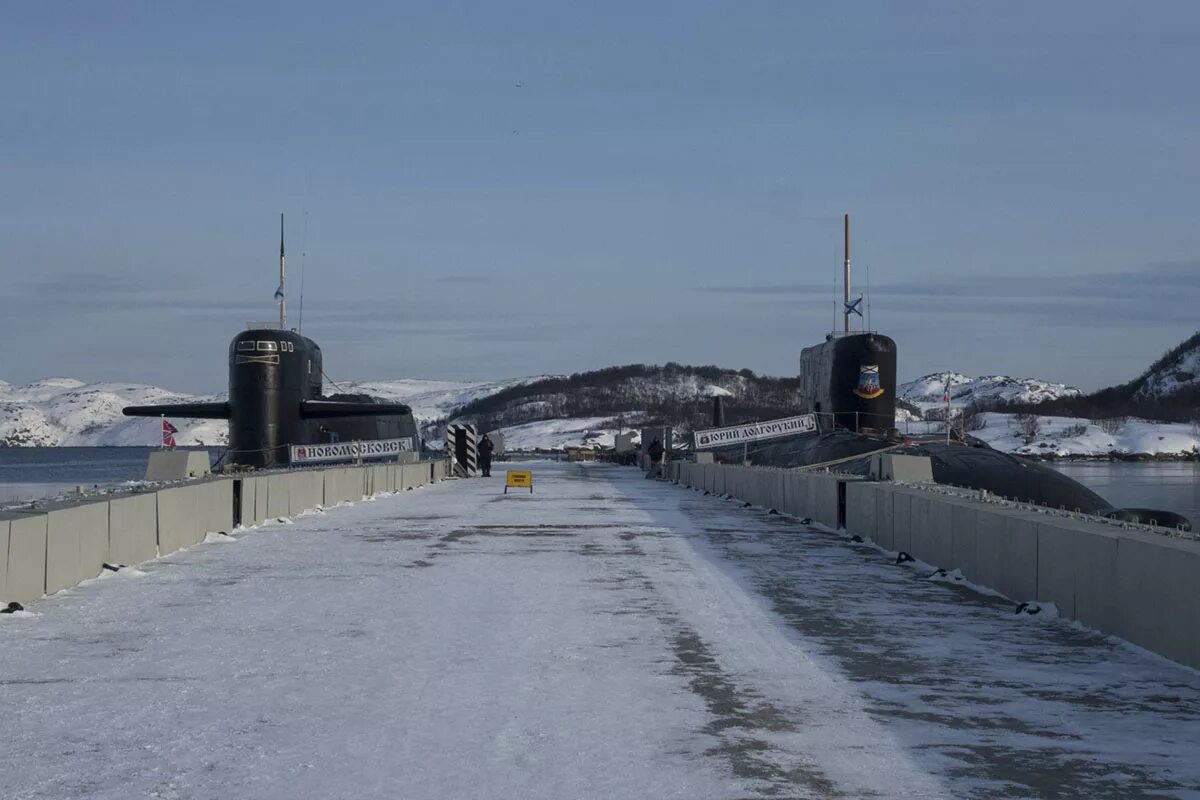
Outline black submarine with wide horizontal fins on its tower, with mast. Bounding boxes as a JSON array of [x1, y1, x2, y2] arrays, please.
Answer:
[[121, 215, 419, 468]]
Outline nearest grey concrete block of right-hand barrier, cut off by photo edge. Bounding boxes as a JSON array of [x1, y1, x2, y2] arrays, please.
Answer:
[[1114, 531, 1200, 668]]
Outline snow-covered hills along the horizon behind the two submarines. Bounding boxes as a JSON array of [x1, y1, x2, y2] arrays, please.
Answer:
[[11, 333, 1200, 449]]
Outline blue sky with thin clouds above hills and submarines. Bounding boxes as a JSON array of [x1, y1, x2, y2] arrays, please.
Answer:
[[0, 0, 1200, 391]]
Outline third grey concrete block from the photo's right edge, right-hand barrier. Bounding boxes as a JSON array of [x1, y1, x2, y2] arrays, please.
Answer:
[[976, 509, 1044, 602]]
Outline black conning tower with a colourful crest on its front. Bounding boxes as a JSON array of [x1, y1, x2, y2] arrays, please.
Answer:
[[800, 332, 896, 432]]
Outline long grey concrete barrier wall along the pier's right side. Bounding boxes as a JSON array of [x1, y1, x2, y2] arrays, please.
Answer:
[[679, 464, 1200, 668]]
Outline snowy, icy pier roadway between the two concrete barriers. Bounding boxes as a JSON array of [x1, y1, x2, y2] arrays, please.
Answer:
[[0, 463, 1200, 800]]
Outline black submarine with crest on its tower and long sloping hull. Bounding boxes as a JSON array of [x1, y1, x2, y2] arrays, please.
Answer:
[[714, 215, 1192, 530]]
